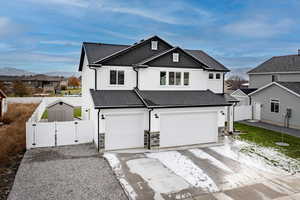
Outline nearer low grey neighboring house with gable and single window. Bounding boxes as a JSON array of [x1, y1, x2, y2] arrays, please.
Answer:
[[250, 81, 300, 129]]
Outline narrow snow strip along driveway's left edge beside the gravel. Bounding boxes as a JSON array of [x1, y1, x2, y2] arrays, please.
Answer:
[[103, 153, 137, 200]]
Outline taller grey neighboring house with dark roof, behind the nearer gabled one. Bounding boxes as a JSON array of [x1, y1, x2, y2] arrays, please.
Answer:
[[248, 51, 300, 88]]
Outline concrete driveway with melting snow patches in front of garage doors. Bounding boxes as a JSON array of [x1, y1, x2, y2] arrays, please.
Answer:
[[104, 141, 300, 200]]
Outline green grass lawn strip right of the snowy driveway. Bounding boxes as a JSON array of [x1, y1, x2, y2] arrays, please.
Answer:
[[234, 123, 300, 159]]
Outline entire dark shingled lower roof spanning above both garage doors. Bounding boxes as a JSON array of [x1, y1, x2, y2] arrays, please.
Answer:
[[90, 89, 231, 109]]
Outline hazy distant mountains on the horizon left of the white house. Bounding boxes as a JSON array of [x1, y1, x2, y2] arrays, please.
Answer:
[[0, 67, 81, 77]]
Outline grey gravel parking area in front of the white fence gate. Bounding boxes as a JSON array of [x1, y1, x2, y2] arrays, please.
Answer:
[[8, 144, 127, 200]]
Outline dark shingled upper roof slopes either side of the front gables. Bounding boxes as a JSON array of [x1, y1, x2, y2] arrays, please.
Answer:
[[79, 37, 229, 71]]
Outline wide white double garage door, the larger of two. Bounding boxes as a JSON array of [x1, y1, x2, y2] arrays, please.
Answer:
[[160, 112, 218, 147]]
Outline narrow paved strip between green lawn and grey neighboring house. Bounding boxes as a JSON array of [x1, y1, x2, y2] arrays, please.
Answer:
[[239, 121, 300, 137]]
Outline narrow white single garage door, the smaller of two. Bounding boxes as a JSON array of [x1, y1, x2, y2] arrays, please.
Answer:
[[105, 113, 144, 150]]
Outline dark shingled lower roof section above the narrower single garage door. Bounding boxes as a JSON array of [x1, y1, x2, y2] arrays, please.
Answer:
[[90, 90, 145, 108]]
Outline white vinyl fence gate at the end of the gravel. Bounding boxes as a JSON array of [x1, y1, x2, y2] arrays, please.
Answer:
[[26, 121, 93, 149]]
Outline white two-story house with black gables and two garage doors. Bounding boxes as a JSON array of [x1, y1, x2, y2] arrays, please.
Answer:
[[79, 36, 236, 150]]
